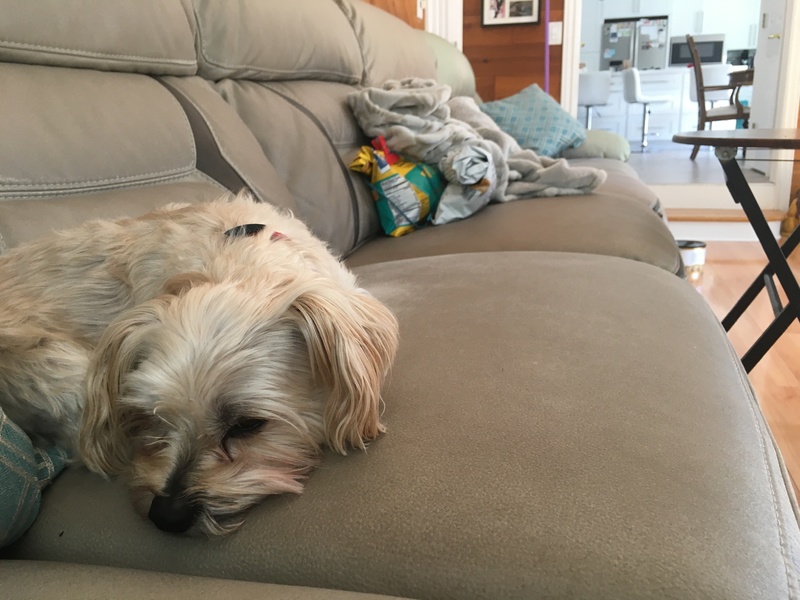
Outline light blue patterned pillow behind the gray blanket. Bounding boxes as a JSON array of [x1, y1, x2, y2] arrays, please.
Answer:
[[481, 83, 586, 157]]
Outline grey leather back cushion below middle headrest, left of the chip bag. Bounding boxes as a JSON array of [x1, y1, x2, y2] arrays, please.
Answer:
[[216, 79, 378, 255]]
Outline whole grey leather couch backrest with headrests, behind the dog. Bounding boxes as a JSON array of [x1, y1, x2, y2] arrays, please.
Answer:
[[0, 0, 474, 255]]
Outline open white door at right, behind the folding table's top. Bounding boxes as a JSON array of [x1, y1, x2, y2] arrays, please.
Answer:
[[747, 0, 787, 175]]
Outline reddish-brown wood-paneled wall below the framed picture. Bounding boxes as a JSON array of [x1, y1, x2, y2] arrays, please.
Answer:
[[464, 0, 564, 101]]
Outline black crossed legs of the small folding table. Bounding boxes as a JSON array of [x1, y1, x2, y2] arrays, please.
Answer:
[[716, 148, 800, 372]]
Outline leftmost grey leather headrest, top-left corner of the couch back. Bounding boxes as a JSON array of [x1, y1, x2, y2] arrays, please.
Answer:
[[0, 0, 197, 75]]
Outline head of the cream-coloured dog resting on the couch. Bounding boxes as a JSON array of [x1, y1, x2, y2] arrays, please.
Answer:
[[80, 278, 397, 535]]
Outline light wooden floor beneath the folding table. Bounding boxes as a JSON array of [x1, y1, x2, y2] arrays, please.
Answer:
[[695, 242, 800, 493]]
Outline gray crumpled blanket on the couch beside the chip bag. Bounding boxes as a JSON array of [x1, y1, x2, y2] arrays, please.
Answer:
[[347, 79, 606, 202]]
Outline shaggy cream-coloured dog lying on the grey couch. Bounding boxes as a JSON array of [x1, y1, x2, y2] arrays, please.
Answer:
[[0, 194, 398, 536]]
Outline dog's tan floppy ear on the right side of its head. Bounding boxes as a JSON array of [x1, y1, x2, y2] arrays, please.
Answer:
[[292, 286, 398, 454]]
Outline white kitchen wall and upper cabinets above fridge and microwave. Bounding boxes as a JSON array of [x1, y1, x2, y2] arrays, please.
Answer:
[[580, 0, 760, 71]]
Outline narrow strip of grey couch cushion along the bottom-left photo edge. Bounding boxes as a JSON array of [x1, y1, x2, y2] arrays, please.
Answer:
[[0, 560, 406, 600]]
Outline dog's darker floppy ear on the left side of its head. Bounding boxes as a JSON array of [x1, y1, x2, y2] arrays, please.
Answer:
[[79, 296, 170, 475]]
